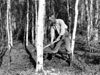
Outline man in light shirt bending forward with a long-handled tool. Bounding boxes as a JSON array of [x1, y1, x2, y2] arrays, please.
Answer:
[[49, 15, 71, 54]]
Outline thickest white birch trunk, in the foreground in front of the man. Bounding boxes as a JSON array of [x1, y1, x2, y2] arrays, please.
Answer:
[[36, 0, 45, 72]]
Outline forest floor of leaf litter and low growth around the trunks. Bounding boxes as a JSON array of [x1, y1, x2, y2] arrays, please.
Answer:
[[0, 43, 100, 75]]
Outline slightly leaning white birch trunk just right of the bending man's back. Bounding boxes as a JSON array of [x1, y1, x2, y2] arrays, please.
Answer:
[[71, 0, 79, 60]]
